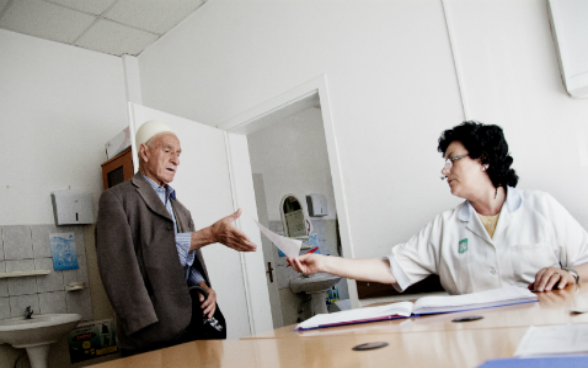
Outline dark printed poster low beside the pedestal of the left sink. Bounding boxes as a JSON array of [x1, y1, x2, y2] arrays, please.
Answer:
[[67, 319, 118, 363]]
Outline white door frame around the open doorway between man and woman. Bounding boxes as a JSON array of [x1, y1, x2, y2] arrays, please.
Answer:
[[217, 74, 359, 308]]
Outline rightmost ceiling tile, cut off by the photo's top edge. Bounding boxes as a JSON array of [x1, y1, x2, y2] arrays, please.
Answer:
[[104, 0, 204, 34]]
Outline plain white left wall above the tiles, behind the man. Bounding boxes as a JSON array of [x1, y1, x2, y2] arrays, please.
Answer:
[[0, 30, 128, 225]]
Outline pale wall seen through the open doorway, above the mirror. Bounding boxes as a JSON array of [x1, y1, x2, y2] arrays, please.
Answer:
[[247, 107, 337, 221]]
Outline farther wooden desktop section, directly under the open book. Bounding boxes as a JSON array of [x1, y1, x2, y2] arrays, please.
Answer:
[[244, 284, 588, 339]]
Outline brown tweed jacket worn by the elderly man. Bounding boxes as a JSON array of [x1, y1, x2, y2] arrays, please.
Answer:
[[96, 174, 210, 349]]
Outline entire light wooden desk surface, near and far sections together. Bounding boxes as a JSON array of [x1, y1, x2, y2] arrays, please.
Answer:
[[95, 285, 588, 368]]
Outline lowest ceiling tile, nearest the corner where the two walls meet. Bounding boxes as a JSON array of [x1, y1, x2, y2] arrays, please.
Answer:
[[76, 19, 159, 56]]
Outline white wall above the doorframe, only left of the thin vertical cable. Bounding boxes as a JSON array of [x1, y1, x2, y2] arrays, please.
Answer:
[[139, 0, 463, 257]]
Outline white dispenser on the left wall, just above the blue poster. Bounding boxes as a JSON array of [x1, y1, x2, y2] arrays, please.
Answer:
[[51, 189, 94, 225]]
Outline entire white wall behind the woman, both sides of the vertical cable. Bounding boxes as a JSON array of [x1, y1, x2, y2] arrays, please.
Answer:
[[139, 0, 588, 264]]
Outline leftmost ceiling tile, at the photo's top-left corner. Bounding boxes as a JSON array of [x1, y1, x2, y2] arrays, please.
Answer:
[[0, 0, 96, 43]]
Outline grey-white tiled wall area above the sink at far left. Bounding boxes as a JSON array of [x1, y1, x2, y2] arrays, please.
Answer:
[[0, 225, 92, 320]]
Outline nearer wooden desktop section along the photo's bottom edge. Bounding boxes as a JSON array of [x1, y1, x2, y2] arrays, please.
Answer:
[[94, 327, 527, 368]]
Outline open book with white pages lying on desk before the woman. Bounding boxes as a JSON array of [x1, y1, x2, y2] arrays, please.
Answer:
[[296, 286, 539, 330]]
